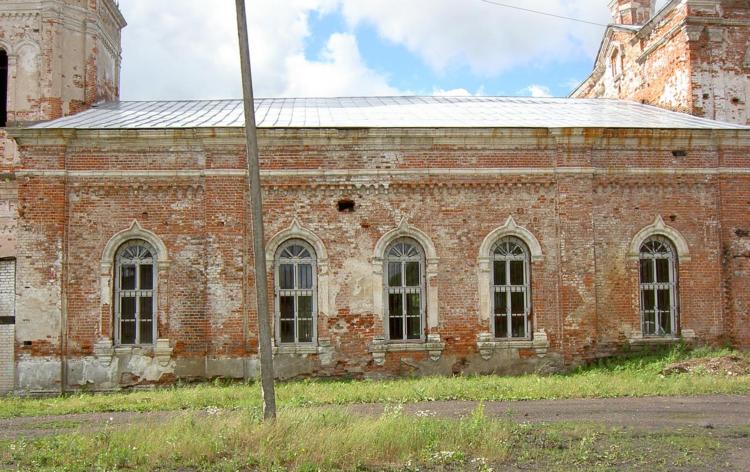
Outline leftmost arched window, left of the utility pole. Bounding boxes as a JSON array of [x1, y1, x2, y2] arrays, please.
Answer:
[[115, 239, 157, 345]]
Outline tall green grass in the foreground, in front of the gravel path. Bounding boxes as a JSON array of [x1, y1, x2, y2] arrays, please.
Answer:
[[0, 405, 736, 472]]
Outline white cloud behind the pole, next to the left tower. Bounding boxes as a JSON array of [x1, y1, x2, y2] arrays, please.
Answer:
[[120, 0, 398, 99]]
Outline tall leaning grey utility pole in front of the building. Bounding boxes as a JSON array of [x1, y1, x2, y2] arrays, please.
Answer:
[[236, 0, 276, 420]]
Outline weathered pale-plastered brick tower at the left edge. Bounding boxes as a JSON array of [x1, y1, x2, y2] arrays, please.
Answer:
[[0, 0, 125, 393]]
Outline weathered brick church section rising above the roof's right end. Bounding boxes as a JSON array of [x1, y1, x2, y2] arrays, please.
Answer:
[[571, 0, 750, 124]]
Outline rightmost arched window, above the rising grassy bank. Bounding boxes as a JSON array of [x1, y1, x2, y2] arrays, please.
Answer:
[[640, 236, 677, 336]]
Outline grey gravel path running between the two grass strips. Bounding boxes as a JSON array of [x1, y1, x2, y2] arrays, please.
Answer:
[[5, 395, 750, 439]]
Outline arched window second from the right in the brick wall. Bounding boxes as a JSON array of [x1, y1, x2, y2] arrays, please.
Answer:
[[492, 237, 531, 339]]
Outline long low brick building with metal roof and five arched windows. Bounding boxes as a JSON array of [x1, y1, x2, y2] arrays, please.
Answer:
[[0, 0, 750, 392]]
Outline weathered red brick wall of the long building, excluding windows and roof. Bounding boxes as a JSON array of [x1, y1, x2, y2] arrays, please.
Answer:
[[7, 130, 750, 390]]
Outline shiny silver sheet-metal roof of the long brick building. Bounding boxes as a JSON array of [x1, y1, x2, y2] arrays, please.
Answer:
[[26, 97, 750, 129]]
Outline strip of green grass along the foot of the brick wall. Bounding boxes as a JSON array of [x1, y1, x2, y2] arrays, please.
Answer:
[[0, 346, 750, 418]]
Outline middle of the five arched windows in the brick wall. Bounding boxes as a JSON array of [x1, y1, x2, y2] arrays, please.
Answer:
[[384, 238, 425, 341]]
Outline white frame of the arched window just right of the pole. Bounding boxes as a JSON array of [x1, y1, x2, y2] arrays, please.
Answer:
[[274, 242, 318, 346]]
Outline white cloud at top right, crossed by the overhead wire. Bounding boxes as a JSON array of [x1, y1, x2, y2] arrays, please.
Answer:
[[342, 0, 609, 76]]
